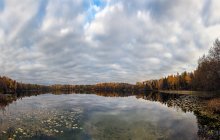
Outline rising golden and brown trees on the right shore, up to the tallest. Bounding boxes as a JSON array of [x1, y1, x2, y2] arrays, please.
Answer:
[[143, 39, 220, 91]]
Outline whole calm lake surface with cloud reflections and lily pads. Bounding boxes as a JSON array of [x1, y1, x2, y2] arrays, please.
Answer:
[[0, 93, 220, 140]]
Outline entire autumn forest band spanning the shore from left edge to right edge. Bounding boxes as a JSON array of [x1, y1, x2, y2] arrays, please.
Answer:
[[0, 39, 220, 94]]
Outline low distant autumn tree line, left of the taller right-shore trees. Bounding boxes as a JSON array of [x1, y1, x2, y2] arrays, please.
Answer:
[[0, 76, 146, 94]]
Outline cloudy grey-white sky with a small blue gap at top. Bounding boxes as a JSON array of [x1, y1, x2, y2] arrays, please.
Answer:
[[0, 0, 220, 84]]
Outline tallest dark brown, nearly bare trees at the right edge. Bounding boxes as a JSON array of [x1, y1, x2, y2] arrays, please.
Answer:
[[193, 39, 220, 90]]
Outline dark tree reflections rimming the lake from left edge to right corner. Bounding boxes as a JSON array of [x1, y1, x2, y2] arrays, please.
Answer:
[[0, 92, 220, 139]]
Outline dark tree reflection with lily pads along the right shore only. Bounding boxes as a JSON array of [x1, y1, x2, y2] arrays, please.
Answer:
[[136, 92, 220, 139]]
